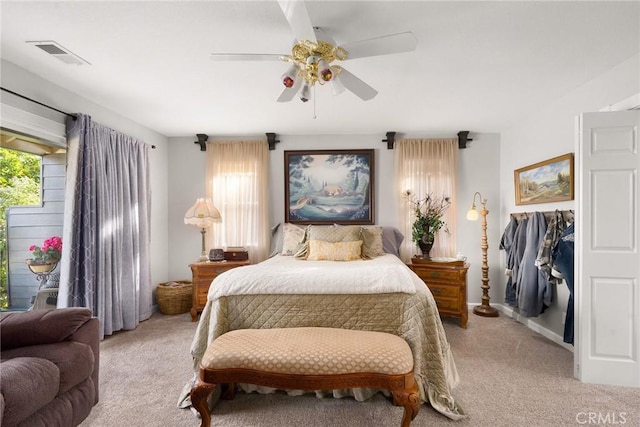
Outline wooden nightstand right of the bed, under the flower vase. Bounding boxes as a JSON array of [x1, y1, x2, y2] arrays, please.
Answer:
[[409, 258, 469, 328]]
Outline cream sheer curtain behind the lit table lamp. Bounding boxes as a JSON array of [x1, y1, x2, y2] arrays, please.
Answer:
[[206, 141, 269, 263]]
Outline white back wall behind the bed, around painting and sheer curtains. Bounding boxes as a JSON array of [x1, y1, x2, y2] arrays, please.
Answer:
[[168, 132, 500, 310]]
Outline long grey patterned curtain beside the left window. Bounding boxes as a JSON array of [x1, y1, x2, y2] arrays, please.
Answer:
[[58, 114, 152, 337]]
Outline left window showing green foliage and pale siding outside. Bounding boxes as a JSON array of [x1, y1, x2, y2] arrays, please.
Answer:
[[0, 128, 66, 309]]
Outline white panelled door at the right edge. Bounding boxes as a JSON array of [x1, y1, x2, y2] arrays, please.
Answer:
[[574, 111, 640, 387]]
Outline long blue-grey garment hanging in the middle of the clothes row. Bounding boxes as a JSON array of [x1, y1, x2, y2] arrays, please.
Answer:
[[515, 212, 553, 317]]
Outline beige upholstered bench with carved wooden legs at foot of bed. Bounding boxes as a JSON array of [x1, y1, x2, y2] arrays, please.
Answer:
[[191, 328, 420, 427]]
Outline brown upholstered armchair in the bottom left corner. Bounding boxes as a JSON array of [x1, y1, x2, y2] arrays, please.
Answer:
[[0, 308, 100, 427]]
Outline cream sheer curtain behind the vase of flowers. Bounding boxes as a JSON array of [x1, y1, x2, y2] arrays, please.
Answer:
[[394, 138, 458, 261]]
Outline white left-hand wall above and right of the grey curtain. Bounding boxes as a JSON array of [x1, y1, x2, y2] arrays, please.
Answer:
[[0, 60, 169, 290]]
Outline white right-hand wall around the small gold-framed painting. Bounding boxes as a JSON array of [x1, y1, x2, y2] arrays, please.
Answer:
[[494, 55, 640, 342]]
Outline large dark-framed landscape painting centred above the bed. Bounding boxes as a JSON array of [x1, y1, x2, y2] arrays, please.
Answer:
[[284, 150, 374, 224]]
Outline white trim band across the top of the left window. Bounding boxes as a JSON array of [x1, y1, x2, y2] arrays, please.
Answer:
[[0, 102, 67, 148]]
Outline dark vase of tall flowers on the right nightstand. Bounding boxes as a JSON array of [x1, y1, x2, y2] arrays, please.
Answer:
[[405, 190, 451, 259]]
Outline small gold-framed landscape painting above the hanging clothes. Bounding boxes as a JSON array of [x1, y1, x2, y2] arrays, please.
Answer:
[[514, 153, 573, 205]]
